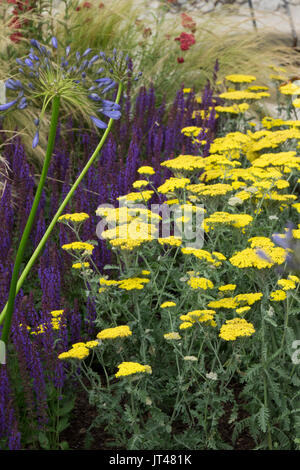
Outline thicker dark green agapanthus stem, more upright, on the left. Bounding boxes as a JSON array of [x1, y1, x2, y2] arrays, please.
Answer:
[[1, 96, 60, 343]]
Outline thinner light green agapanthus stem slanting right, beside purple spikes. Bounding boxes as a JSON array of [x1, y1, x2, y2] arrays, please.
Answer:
[[0, 82, 123, 332]]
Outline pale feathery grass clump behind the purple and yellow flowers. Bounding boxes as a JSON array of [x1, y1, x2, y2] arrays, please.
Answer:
[[57, 0, 296, 100]]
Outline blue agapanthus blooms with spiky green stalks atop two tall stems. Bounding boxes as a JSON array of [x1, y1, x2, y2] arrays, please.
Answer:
[[0, 37, 132, 148]]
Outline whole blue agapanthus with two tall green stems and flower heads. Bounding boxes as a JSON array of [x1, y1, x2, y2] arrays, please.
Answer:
[[0, 37, 140, 343]]
